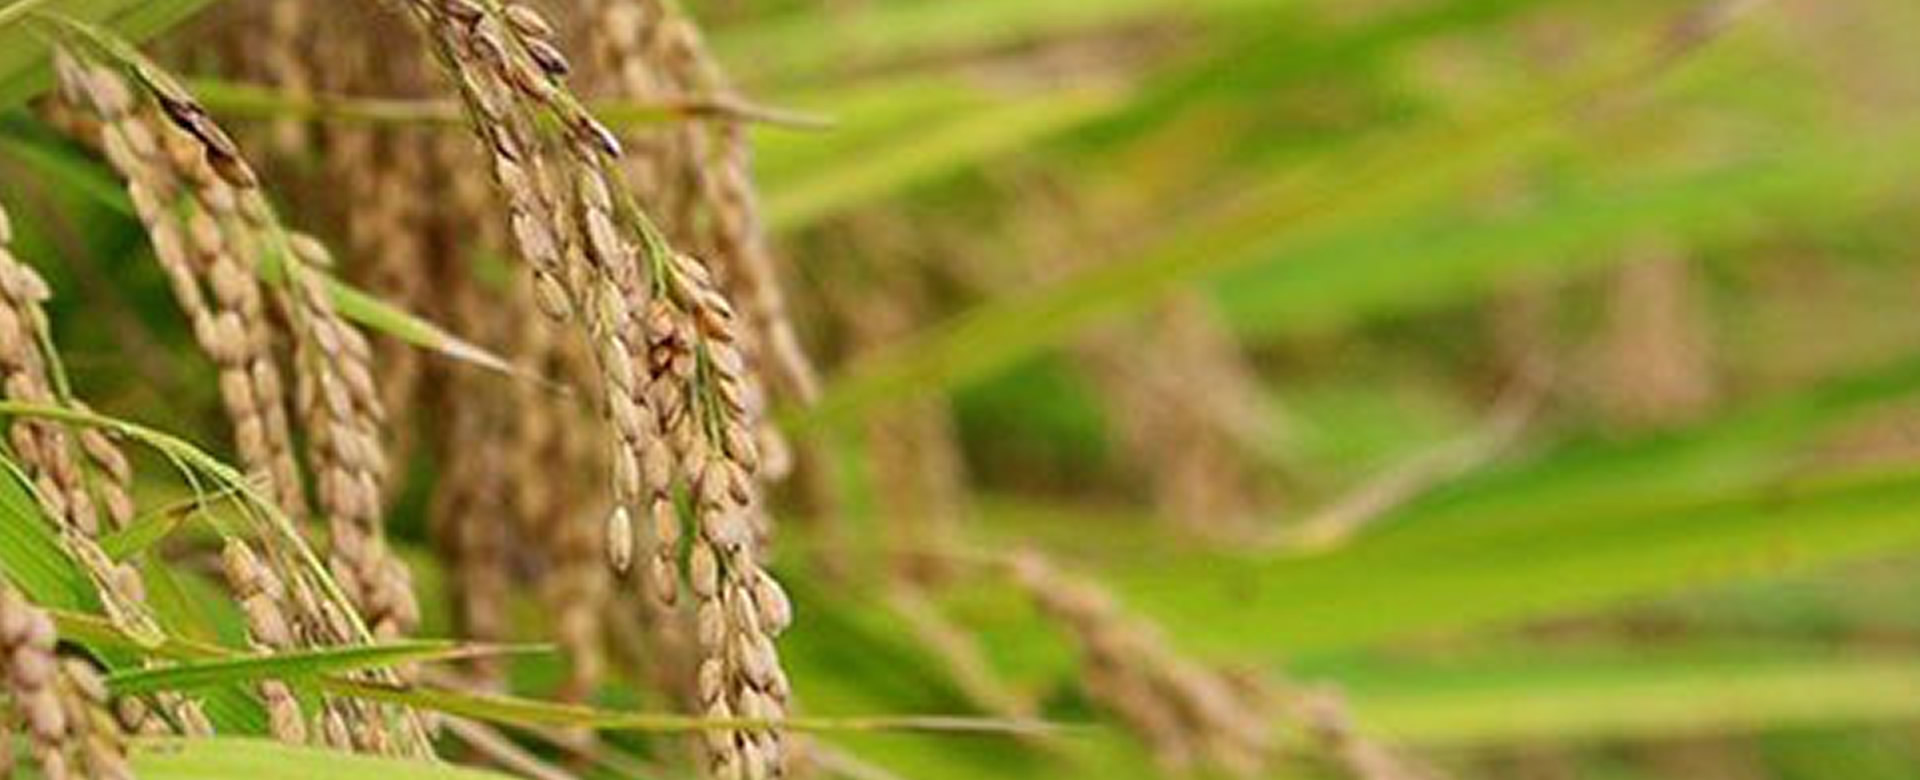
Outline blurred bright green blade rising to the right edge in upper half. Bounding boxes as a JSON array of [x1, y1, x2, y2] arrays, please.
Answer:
[[1213, 127, 1920, 338]]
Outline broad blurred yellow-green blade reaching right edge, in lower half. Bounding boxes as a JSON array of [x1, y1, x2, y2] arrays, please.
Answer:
[[1104, 466, 1920, 655]]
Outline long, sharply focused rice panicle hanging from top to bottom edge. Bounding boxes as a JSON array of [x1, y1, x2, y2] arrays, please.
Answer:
[[393, 0, 791, 776]]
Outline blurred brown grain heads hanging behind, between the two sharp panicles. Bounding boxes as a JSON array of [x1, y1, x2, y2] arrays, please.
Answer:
[[215, 4, 616, 699]]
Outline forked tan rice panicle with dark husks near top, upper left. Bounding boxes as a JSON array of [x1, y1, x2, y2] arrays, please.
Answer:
[[58, 45, 417, 636]]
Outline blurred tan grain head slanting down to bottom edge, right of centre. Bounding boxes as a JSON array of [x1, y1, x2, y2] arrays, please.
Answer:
[[1014, 553, 1273, 776]]
